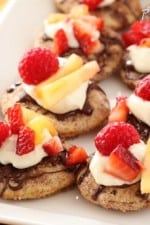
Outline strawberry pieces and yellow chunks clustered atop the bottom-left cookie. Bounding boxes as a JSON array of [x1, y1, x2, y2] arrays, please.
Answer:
[[7, 103, 57, 155]]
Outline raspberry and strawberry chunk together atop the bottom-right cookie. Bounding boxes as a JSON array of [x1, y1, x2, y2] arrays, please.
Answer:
[[95, 122, 142, 182]]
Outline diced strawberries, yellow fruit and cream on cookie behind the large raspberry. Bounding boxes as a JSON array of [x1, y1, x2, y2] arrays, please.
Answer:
[[47, 4, 103, 55]]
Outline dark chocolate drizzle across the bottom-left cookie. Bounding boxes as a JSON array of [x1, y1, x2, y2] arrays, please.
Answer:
[[0, 150, 76, 196]]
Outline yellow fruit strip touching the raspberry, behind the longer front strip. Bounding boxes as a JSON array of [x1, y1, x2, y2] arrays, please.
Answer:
[[35, 54, 83, 90]]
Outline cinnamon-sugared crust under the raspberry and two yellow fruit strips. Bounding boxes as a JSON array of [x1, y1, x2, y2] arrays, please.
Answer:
[[1, 85, 110, 138]]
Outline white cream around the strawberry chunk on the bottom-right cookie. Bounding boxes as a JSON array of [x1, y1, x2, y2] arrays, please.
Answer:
[[89, 141, 146, 186]]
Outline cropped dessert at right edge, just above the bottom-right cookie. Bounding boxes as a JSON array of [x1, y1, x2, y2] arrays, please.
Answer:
[[109, 75, 150, 143]]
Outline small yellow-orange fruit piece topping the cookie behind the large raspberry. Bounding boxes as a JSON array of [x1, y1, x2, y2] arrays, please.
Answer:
[[70, 4, 89, 19]]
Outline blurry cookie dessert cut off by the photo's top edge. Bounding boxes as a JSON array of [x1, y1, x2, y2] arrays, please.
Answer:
[[55, 0, 141, 30]]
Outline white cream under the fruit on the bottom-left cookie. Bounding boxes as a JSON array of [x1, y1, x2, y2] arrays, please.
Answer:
[[0, 129, 51, 169]]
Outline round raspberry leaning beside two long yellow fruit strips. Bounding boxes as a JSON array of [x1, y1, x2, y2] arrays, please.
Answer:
[[18, 48, 59, 85]]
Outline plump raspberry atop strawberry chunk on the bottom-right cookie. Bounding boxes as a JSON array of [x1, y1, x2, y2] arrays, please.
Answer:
[[95, 122, 140, 156]]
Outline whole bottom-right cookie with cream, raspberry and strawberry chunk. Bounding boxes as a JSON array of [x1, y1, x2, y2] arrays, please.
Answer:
[[77, 122, 150, 212]]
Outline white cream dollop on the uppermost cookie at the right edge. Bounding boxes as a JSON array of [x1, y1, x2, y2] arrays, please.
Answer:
[[127, 45, 150, 73]]
